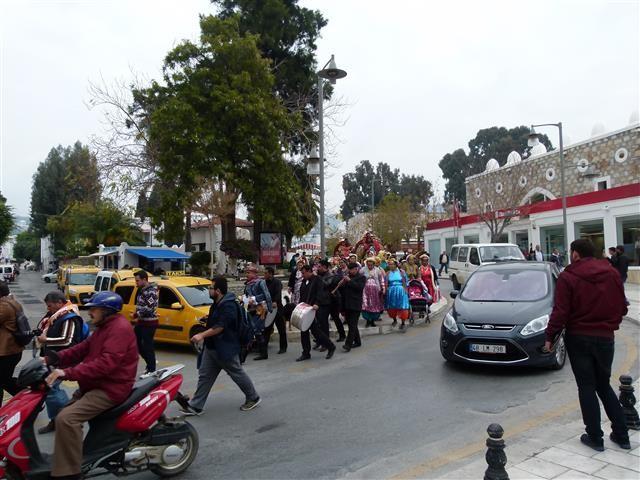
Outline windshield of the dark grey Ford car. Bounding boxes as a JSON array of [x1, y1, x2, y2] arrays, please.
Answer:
[[461, 269, 549, 302]]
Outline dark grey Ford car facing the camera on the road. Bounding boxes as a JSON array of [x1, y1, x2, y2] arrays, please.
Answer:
[[440, 262, 566, 369]]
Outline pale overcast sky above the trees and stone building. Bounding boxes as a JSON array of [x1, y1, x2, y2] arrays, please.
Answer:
[[0, 0, 640, 215]]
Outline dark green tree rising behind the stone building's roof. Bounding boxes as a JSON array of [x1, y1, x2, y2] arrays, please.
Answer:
[[438, 126, 553, 210]]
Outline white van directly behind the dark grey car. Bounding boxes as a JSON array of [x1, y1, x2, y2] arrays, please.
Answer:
[[449, 243, 527, 290]]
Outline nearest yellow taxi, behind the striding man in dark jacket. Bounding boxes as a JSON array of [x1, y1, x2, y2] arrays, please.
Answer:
[[114, 276, 213, 345]]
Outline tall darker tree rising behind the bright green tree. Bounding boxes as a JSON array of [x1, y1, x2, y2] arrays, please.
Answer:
[[212, 0, 332, 152]]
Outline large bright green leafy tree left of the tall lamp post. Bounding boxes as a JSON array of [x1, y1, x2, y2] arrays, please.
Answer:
[[142, 16, 303, 249]]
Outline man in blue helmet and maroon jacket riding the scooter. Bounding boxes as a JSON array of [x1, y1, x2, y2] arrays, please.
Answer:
[[45, 292, 138, 479]]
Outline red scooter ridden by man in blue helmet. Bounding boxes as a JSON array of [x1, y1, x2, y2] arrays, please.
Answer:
[[0, 359, 198, 480]]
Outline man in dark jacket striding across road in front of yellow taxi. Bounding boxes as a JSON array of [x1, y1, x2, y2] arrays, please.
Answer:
[[181, 276, 261, 415]]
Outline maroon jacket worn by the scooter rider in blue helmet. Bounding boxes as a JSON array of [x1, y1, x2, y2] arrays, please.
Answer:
[[58, 314, 138, 403]]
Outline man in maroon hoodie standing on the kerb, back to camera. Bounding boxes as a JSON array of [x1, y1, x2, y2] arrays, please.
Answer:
[[545, 239, 631, 452]]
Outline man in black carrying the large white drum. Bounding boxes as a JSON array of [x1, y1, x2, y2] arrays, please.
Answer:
[[296, 260, 336, 362]]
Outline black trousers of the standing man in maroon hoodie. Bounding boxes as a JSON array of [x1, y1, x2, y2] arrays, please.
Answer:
[[565, 335, 628, 439]]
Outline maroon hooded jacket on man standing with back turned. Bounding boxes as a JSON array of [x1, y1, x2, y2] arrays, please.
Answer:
[[546, 258, 627, 341]]
